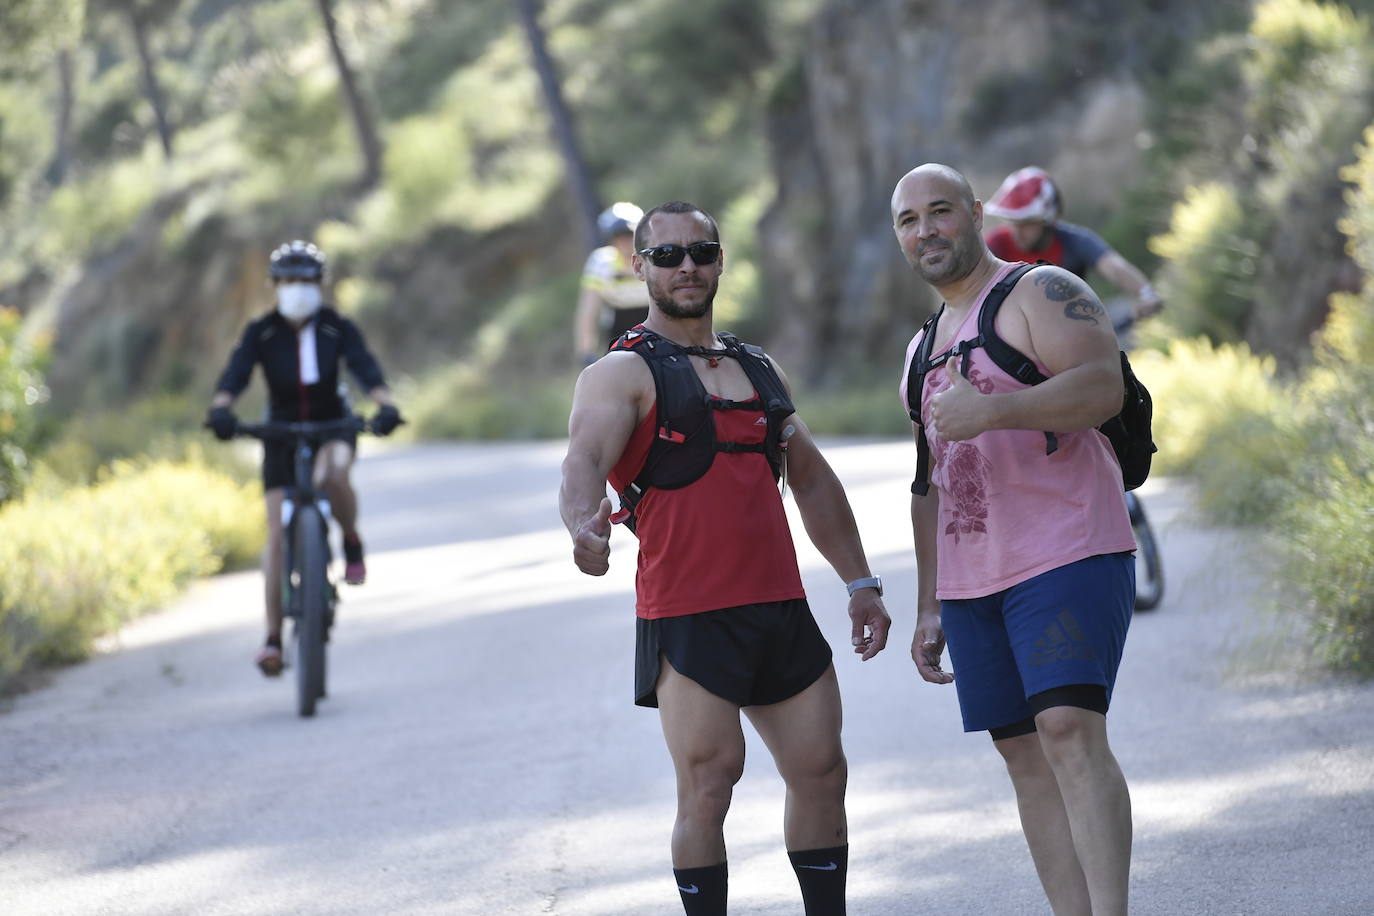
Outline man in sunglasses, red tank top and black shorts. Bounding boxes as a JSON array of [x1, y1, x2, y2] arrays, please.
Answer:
[[559, 202, 890, 916]]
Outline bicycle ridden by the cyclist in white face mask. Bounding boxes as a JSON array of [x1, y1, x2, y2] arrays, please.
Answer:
[[236, 415, 371, 717]]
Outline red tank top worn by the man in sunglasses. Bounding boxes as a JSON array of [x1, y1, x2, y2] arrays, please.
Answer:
[[607, 398, 807, 619]]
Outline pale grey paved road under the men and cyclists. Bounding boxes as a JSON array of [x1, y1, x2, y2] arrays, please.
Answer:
[[0, 442, 1374, 916]]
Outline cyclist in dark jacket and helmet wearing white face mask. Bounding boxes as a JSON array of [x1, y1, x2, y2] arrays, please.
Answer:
[[206, 240, 401, 677]]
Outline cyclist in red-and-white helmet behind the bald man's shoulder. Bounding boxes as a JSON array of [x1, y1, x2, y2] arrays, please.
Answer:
[[984, 165, 1164, 319]]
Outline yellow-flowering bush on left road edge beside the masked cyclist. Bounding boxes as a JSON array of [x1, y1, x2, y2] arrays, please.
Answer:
[[0, 461, 265, 689]]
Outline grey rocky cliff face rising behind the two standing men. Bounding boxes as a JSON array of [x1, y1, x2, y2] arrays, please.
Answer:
[[761, 0, 1186, 385]]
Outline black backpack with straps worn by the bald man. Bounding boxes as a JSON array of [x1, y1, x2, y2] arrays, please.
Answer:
[[907, 264, 1158, 496]]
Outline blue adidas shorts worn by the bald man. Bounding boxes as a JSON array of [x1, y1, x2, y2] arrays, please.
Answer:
[[940, 553, 1135, 732]]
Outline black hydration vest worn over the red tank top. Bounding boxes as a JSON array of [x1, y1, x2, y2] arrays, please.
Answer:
[[610, 327, 796, 531]]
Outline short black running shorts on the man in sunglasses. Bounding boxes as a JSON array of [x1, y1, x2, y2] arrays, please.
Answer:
[[635, 597, 831, 706]]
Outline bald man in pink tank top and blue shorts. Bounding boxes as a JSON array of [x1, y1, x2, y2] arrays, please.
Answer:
[[892, 163, 1135, 916]]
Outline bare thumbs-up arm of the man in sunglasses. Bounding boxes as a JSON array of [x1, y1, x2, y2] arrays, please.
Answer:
[[558, 353, 653, 575]]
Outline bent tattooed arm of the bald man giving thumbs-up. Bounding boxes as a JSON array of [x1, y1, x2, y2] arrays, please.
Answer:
[[932, 266, 1123, 441]]
